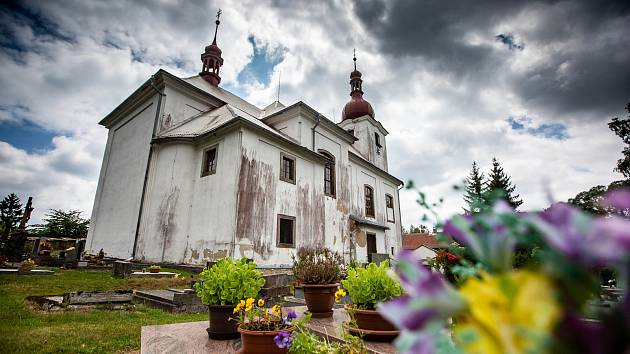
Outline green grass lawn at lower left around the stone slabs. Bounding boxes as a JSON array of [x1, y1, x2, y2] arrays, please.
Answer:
[[0, 269, 208, 353]]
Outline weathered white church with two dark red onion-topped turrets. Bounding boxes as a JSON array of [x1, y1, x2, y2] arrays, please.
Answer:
[[86, 16, 403, 267]]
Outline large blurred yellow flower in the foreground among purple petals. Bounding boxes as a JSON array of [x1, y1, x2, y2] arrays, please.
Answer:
[[455, 271, 561, 354]]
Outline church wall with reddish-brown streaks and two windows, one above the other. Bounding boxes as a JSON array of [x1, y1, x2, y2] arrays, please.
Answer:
[[235, 130, 327, 265]]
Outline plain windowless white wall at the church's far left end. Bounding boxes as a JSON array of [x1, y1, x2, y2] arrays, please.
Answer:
[[86, 95, 158, 258]]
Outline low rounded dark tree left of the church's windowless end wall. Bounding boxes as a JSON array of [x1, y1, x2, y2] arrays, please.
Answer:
[[34, 209, 90, 238]]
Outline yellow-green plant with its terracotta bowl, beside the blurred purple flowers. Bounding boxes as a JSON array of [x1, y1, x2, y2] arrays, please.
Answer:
[[338, 261, 402, 331]]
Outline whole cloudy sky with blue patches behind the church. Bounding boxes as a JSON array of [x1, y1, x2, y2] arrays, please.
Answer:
[[0, 0, 630, 226]]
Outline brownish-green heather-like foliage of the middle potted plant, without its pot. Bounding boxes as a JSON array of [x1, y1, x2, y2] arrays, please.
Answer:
[[293, 248, 342, 284]]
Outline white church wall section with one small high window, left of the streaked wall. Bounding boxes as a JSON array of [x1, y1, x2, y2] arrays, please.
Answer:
[[136, 131, 240, 264]]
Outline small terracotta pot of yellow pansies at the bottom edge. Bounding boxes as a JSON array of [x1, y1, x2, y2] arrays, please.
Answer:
[[233, 297, 297, 354]]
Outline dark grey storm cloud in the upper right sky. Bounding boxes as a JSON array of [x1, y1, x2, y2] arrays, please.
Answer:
[[354, 0, 630, 119]]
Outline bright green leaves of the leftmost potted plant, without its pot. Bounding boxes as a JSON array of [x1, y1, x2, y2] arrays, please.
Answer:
[[195, 257, 265, 305]]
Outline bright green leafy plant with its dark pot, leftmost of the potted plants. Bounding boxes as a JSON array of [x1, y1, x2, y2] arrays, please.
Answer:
[[194, 257, 265, 339]]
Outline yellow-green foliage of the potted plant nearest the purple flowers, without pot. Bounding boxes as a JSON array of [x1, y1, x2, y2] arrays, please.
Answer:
[[341, 261, 402, 310]]
